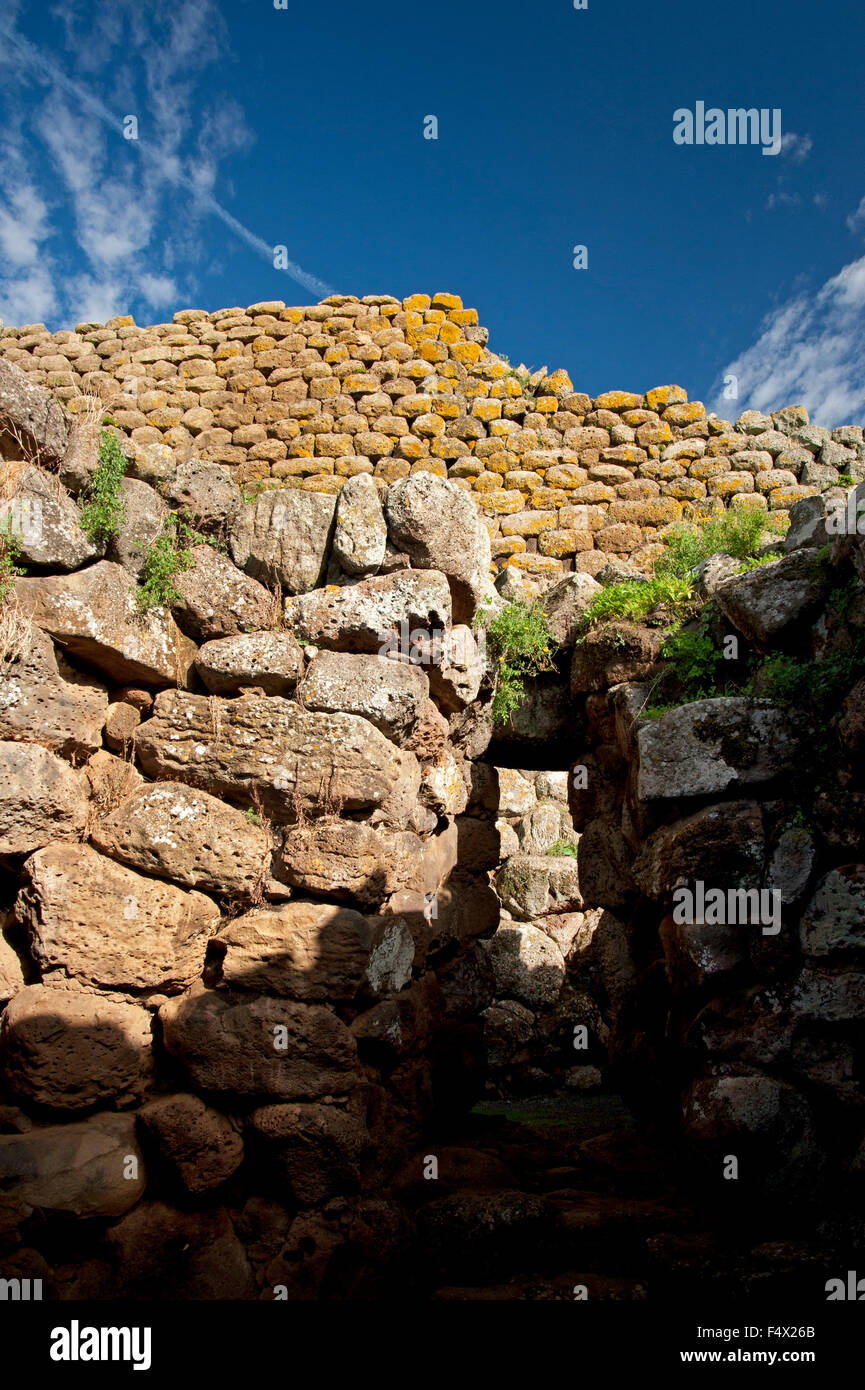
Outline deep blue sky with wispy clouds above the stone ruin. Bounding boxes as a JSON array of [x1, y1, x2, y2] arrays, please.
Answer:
[[0, 0, 865, 424]]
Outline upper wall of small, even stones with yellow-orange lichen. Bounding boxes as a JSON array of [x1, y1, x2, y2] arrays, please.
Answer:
[[6, 293, 865, 578]]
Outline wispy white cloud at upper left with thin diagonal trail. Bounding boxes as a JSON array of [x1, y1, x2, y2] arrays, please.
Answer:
[[0, 0, 331, 322]]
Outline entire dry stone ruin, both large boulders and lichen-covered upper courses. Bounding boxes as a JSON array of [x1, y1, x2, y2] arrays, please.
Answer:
[[0, 293, 865, 1300]]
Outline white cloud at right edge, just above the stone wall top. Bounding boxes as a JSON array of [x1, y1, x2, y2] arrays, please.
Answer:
[[715, 256, 865, 427]]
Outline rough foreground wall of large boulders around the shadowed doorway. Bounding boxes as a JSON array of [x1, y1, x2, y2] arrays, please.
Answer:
[[0, 318, 865, 1298]]
